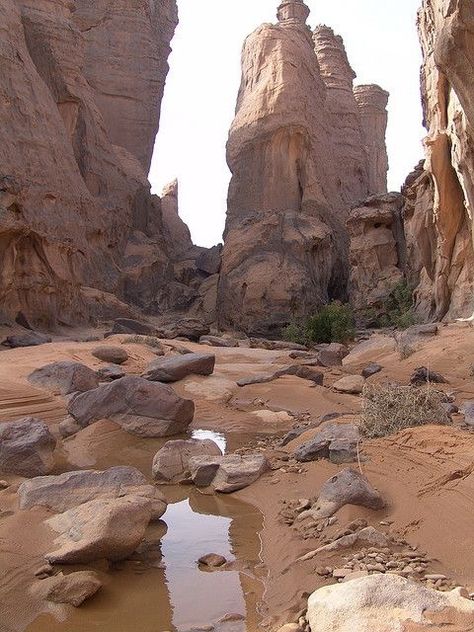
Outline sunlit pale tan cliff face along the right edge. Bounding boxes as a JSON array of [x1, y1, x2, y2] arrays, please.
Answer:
[[404, 0, 474, 320]]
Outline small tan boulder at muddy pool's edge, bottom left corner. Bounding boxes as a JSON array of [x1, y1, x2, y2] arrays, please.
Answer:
[[33, 571, 102, 608]]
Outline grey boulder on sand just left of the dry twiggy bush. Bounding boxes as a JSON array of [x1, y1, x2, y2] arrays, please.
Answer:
[[294, 424, 360, 463]]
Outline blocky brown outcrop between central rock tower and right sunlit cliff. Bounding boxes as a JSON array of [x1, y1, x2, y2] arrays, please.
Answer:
[[347, 193, 405, 319]]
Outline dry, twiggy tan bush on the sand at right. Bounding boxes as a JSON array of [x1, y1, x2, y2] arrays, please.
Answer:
[[362, 384, 450, 438]]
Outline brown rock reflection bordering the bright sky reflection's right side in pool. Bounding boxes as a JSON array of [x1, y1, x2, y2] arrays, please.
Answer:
[[189, 492, 263, 632]]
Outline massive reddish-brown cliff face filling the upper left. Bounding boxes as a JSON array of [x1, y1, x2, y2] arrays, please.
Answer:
[[0, 0, 180, 326]]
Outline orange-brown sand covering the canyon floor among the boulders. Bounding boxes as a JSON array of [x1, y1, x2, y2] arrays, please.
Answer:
[[0, 325, 474, 632]]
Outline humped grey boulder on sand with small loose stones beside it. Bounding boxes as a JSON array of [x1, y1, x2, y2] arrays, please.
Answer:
[[299, 468, 385, 520]]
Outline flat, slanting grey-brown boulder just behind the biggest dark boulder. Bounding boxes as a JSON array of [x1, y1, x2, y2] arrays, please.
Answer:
[[142, 353, 216, 382]]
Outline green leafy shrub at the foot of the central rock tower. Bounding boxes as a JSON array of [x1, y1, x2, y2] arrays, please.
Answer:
[[282, 301, 355, 344]]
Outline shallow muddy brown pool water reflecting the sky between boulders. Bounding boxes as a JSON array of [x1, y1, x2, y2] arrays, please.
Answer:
[[27, 424, 264, 632]]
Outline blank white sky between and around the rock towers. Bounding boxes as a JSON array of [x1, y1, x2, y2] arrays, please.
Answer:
[[150, 0, 424, 246]]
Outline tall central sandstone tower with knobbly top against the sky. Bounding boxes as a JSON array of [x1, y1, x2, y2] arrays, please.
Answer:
[[218, 0, 386, 334]]
